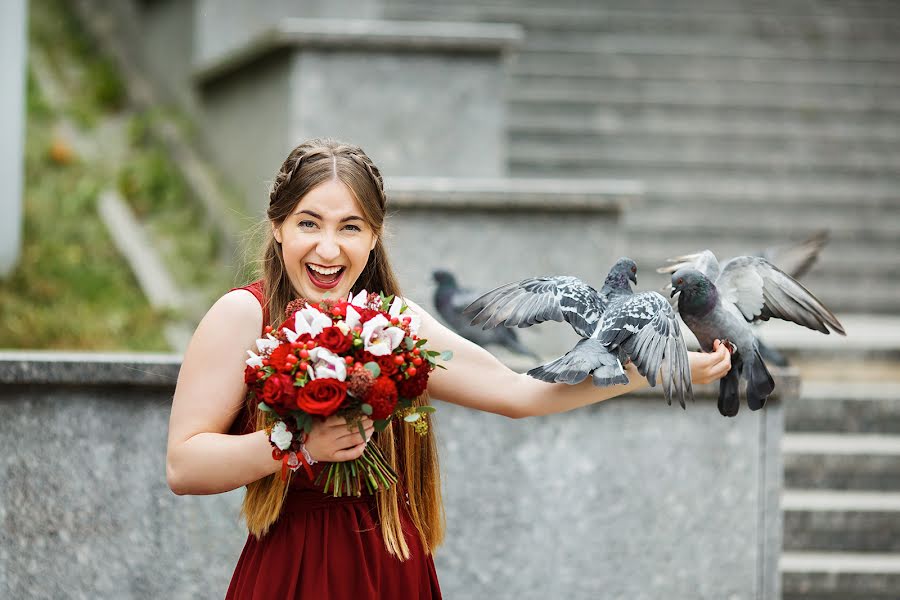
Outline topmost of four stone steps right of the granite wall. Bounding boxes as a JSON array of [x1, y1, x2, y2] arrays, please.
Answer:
[[784, 384, 900, 436]]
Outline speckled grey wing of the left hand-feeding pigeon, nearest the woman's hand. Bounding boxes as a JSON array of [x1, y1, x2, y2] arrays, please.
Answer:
[[599, 292, 694, 408]]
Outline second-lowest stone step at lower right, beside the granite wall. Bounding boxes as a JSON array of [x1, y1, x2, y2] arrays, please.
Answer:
[[781, 490, 900, 552]]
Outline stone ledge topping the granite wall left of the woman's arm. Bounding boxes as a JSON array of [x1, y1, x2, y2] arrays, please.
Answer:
[[0, 350, 181, 388]]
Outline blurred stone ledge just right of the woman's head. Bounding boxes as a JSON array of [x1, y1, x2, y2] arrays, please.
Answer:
[[385, 177, 644, 214]]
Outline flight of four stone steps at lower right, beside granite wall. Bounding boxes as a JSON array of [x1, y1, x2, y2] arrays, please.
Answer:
[[781, 383, 900, 600]]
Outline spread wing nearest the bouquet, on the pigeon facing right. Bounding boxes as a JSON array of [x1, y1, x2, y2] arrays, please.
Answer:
[[463, 276, 607, 337]]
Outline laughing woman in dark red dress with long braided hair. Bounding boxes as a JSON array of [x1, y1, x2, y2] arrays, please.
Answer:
[[166, 140, 730, 600]]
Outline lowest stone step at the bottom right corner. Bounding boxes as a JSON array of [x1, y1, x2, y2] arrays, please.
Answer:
[[779, 552, 900, 600]]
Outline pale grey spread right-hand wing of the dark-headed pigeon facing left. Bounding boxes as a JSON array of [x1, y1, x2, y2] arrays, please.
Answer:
[[715, 256, 845, 335]]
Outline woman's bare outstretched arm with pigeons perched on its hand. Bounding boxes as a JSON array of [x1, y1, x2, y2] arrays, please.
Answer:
[[407, 300, 731, 418]]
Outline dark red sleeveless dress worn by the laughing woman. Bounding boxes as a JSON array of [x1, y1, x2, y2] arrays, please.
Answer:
[[226, 281, 441, 600]]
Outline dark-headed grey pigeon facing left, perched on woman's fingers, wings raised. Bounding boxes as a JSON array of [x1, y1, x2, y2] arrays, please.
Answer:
[[672, 250, 846, 417]]
